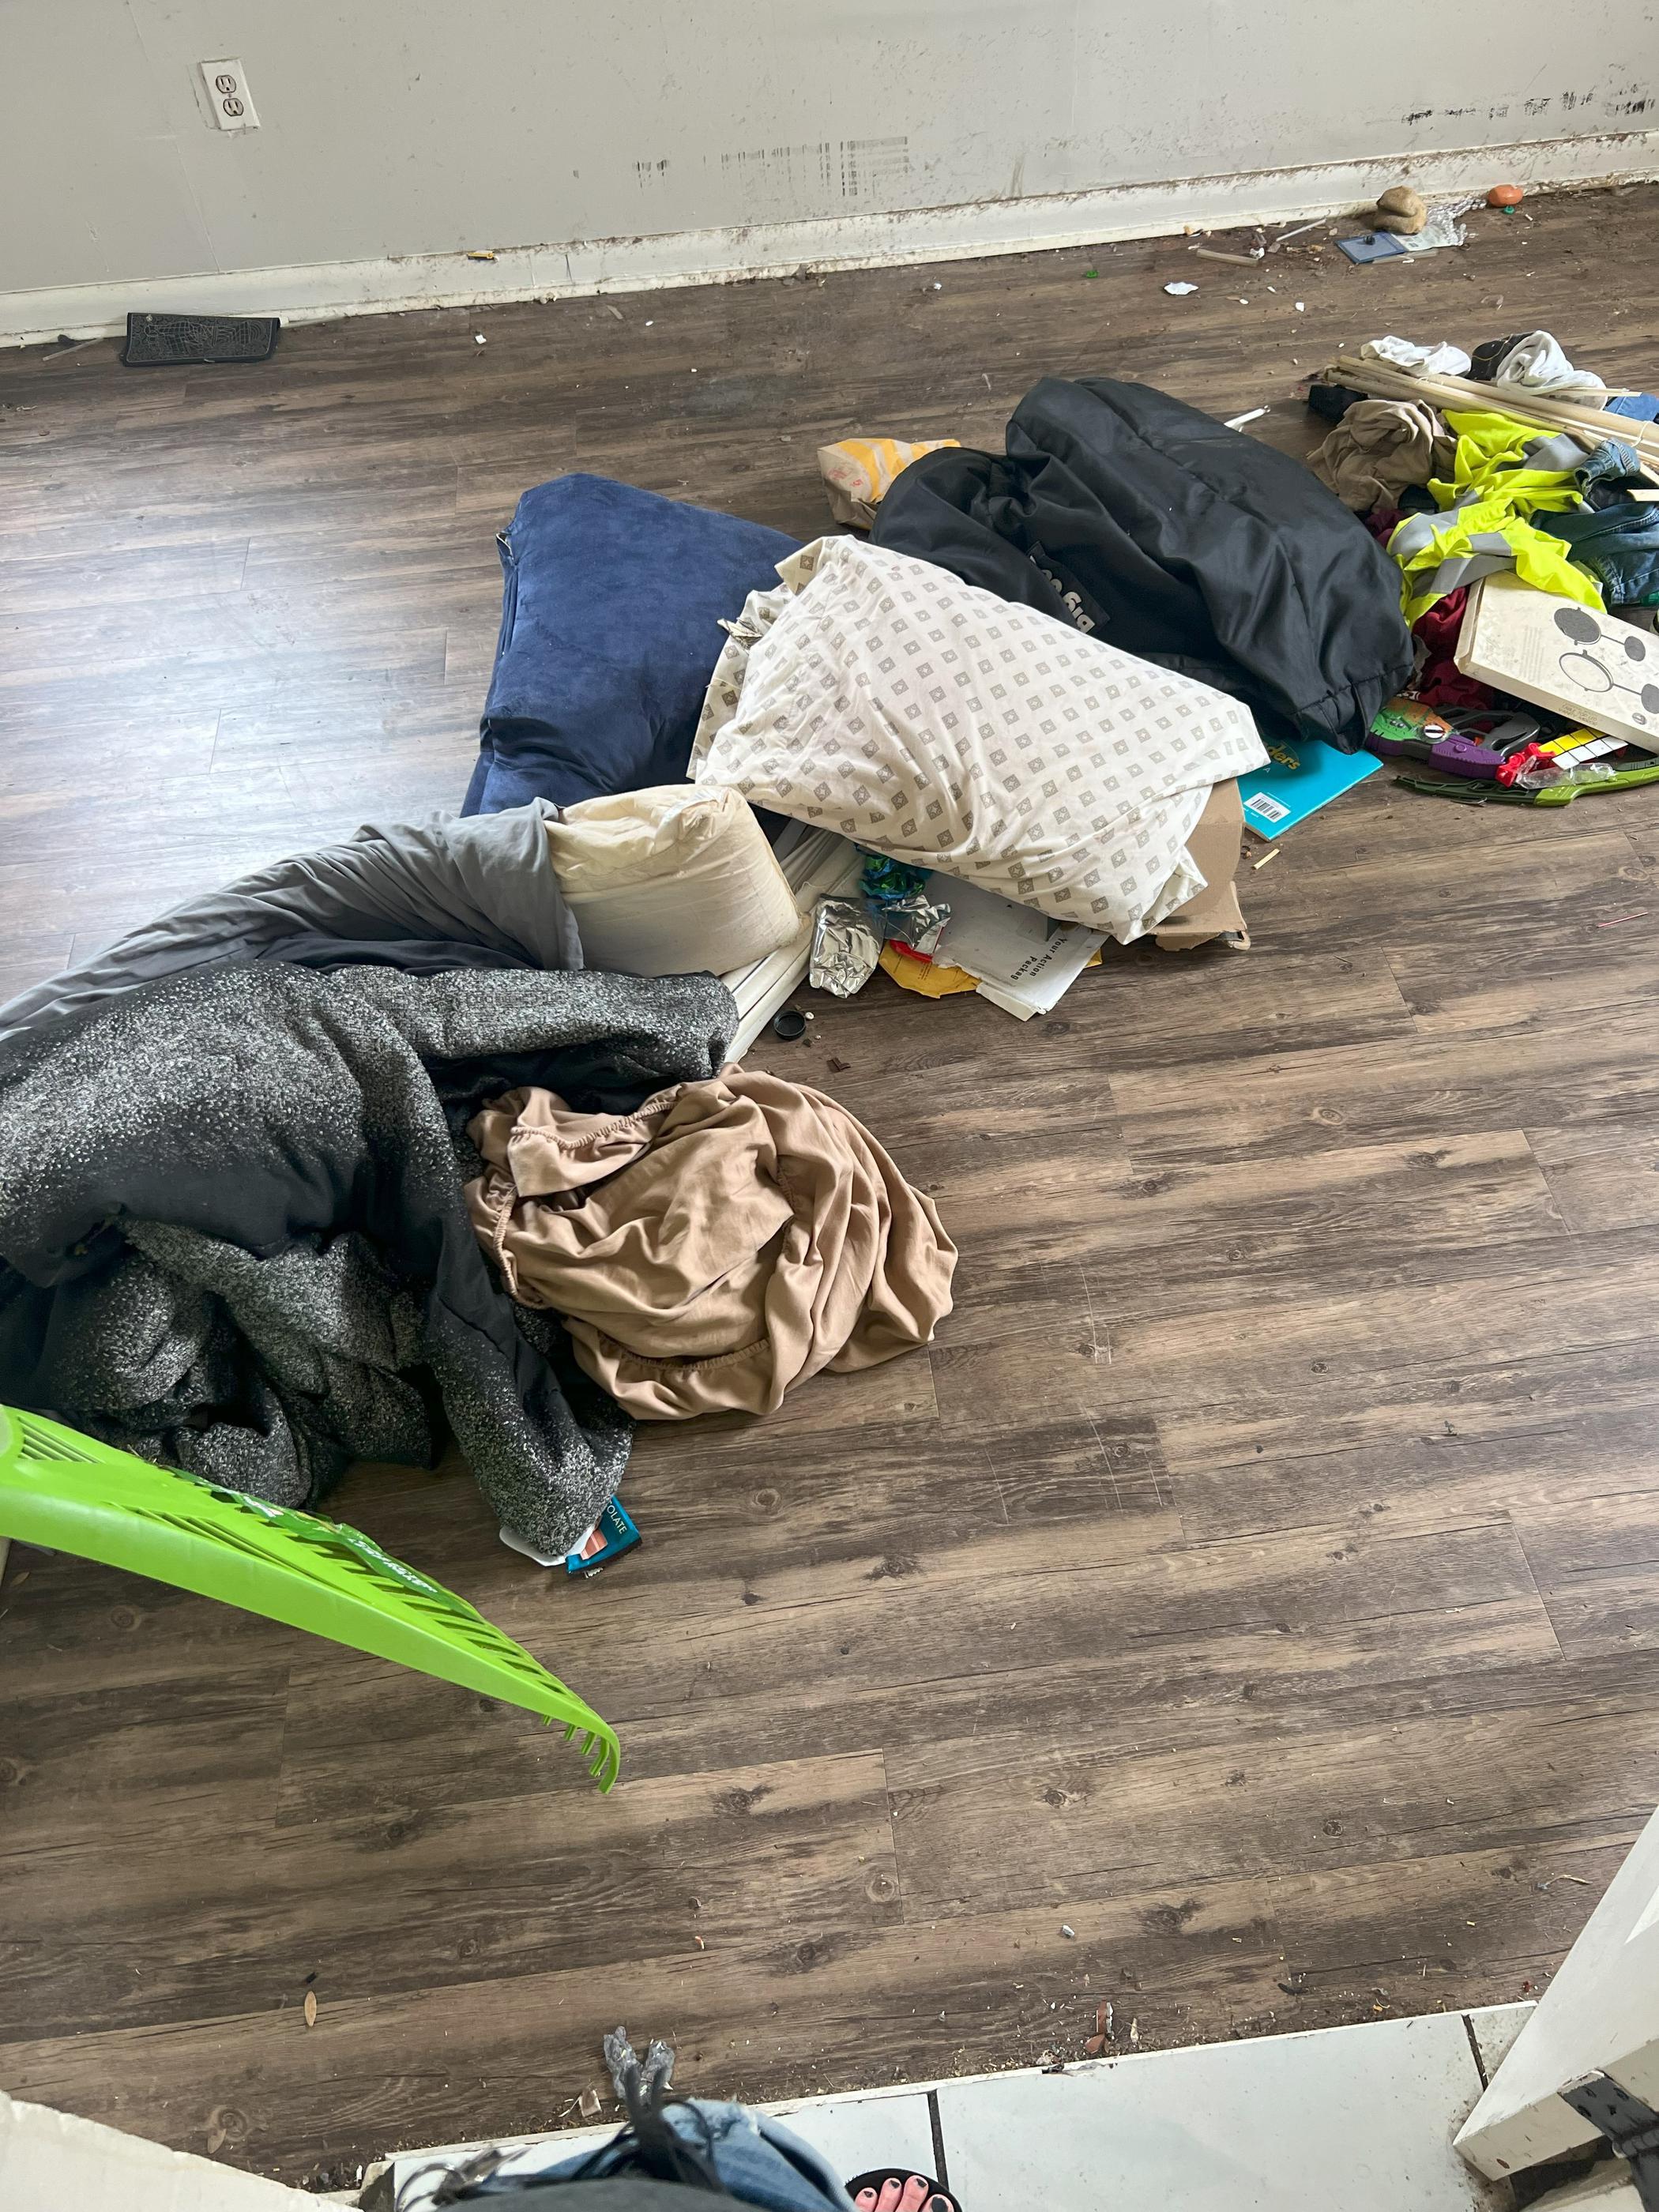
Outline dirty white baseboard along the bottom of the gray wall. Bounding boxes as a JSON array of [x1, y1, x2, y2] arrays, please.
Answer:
[[0, 130, 1659, 345]]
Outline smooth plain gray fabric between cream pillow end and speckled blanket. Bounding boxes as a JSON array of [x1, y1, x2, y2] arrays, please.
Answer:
[[0, 799, 581, 1040]]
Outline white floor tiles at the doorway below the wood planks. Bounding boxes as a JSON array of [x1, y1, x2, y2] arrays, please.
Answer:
[[382, 2004, 1531, 2212]]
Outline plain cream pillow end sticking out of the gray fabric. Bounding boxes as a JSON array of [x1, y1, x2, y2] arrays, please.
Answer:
[[547, 783, 803, 976]]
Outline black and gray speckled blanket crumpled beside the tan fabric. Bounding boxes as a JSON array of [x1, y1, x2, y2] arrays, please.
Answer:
[[0, 964, 735, 1551]]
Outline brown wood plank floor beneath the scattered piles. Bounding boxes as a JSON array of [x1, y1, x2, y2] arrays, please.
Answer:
[[0, 190, 1659, 2176]]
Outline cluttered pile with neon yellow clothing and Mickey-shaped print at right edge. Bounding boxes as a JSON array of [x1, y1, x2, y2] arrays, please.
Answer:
[[1310, 329, 1659, 803]]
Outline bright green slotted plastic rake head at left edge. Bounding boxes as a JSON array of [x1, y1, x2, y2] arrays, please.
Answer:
[[0, 1407, 622, 1792]]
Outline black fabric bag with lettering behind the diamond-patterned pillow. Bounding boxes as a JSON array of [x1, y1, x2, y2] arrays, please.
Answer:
[[871, 376, 1411, 752]]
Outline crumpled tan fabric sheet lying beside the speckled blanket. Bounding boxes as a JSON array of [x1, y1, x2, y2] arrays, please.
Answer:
[[467, 1068, 956, 1420]]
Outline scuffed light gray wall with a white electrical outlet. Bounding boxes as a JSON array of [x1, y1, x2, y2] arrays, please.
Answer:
[[0, 0, 1659, 322]]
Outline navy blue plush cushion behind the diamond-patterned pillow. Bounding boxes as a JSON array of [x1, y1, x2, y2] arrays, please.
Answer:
[[462, 476, 796, 814]]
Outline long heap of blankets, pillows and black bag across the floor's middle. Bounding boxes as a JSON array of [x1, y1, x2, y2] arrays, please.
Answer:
[[0, 378, 1411, 1557]]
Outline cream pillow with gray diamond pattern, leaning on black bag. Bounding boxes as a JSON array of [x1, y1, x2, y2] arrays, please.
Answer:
[[692, 537, 1267, 945]]
